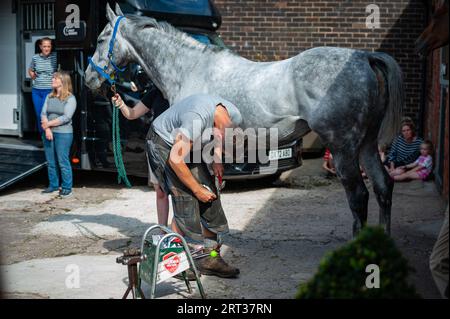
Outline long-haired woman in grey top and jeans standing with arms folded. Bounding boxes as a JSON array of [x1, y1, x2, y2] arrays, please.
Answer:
[[41, 72, 77, 197]]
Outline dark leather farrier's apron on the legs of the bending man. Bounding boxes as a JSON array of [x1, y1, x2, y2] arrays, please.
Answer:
[[147, 128, 228, 241]]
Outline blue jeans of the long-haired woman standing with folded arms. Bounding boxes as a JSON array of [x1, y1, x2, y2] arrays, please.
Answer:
[[42, 133, 73, 191]]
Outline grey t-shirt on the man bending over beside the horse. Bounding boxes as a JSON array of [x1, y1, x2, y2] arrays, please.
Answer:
[[152, 94, 242, 146]]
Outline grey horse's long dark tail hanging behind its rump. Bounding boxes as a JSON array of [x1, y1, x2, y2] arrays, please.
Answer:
[[369, 52, 405, 145]]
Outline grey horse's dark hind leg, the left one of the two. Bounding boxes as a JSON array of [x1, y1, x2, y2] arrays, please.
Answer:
[[333, 151, 369, 236]]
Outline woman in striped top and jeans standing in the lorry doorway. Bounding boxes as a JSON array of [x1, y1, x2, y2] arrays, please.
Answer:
[[28, 38, 56, 135]]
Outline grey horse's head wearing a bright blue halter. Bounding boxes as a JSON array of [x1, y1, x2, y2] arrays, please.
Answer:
[[85, 4, 128, 90]]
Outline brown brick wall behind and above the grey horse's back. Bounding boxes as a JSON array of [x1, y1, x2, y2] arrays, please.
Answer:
[[214, 0, 426, 121]]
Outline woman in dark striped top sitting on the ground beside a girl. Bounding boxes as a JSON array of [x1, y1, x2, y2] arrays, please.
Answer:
[[384, 121, 423, 172]]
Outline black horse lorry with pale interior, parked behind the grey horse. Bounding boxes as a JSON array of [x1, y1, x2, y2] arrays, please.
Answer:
[[0, 0, 301, 190]]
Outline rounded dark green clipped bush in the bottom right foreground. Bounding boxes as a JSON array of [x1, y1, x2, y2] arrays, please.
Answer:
[[296, 227, 419, 299]]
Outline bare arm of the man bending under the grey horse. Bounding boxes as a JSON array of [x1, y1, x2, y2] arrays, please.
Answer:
[[168, 133, 216, 203]]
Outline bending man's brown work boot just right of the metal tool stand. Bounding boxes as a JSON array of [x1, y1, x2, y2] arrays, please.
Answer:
[[194, 248, 240, 278]]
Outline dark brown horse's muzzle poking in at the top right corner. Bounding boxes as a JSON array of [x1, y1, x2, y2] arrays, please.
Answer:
[[415, 0, 448, 58]]
